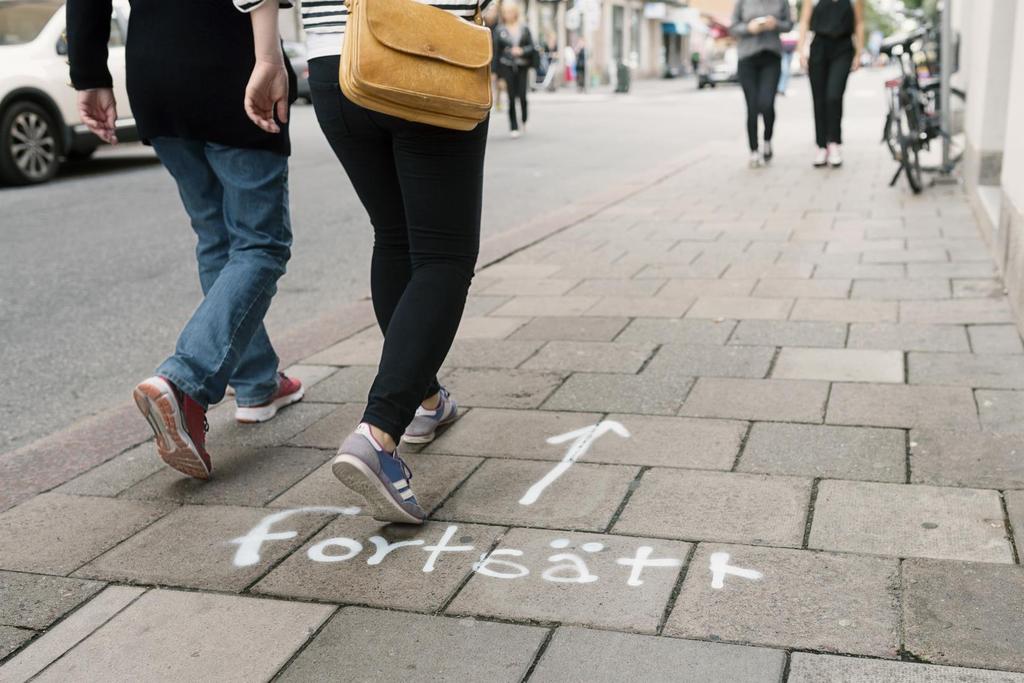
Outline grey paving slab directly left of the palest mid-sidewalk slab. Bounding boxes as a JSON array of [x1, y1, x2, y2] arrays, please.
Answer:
[[643, 344, 775, 379]]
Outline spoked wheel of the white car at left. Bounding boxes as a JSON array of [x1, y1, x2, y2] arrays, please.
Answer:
[[0, 101, 60, 185]]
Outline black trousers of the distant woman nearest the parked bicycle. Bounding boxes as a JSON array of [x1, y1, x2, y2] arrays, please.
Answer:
[[807, 36, 853, 147]]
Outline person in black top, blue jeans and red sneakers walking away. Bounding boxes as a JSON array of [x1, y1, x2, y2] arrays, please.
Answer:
[[67, 0, 303, 479]]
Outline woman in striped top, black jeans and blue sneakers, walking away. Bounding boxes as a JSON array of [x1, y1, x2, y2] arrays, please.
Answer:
[[233, 0, 487, 523]]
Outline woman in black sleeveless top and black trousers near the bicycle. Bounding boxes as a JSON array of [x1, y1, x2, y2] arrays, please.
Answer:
[[797, 0, 864, 168]]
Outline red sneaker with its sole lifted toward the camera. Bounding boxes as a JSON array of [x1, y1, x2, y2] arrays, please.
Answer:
[[133, 377, 213, 479]]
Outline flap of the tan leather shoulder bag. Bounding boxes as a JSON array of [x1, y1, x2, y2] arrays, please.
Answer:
[[359, 0, 492, 69]]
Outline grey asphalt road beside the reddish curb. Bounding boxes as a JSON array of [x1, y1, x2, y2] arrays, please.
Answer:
[[0, 73, 881, 452]]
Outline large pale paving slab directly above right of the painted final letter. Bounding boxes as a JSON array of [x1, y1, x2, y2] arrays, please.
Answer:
[[808, 481, 1014, 562]]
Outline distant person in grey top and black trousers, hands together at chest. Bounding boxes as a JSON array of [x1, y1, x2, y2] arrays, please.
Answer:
[[730, 0, 793, 168]]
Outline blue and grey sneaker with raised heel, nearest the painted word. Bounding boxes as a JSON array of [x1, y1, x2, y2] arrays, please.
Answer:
[[331, 423, 427, 524]]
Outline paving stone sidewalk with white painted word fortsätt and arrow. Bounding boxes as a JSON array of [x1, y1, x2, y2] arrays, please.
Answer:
[[0, 140, 1024, 683]]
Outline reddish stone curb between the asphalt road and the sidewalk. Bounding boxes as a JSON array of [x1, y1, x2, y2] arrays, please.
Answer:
[[0, 144, 710, 512]]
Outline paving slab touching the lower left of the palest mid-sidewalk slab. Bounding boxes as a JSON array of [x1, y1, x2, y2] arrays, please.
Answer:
[[680, 378, 828, 422]]
